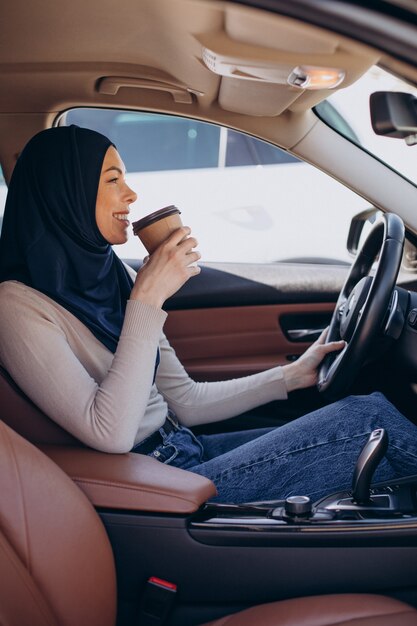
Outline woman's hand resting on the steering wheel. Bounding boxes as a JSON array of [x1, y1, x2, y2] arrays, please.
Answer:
[[282, 328, 346, 392]]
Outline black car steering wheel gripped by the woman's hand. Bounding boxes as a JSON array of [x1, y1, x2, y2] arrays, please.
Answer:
[[317, 213, 405, 397]]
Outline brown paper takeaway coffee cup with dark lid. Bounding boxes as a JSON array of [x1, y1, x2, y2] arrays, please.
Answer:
[[132, 204, 182, 254]]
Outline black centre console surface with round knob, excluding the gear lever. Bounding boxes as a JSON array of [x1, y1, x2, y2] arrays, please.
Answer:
[[189, 476, 417, 546]]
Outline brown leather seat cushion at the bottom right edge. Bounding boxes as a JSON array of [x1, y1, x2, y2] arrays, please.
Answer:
[[205, 594, 417, 626]]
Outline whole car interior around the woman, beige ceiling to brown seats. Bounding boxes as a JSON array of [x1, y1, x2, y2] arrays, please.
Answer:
[[0, 0, 417, 626]]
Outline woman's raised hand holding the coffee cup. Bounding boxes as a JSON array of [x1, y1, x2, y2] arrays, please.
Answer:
[[130, 226, 201, 307]]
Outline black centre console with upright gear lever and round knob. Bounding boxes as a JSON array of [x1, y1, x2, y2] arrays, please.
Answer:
[[190, 428, 417, 543]]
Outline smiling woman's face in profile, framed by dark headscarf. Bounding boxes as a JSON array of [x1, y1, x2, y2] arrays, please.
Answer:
[[96, 146, 137, 245]]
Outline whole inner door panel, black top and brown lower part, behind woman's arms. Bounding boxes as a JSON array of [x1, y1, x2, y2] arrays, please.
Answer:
[[125, 261, 347, 381]]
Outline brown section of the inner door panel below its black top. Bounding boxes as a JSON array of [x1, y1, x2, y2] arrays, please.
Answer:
[[165, 302, 334, 381]]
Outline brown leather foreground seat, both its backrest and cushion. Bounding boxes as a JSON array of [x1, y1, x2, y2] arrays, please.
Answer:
[[0, 422, 417, 626]]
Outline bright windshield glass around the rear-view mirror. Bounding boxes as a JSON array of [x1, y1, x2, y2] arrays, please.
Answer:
[[316, 66, 417, 184]]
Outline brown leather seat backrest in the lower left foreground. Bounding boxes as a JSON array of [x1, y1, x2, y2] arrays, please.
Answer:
[[0, 422, 116, 626]]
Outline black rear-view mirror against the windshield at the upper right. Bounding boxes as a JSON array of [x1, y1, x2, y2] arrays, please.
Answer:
[[369, 91, 417, 146]]
